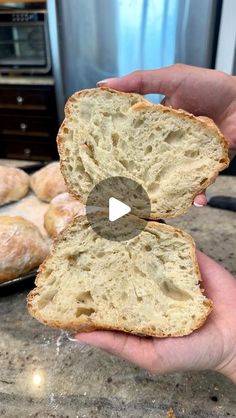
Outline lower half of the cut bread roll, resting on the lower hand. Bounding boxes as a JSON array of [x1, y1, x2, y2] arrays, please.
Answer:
[[28, 215, 212, 337]]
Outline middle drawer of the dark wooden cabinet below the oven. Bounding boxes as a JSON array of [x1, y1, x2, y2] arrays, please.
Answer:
[[0, 115, 55, 140]]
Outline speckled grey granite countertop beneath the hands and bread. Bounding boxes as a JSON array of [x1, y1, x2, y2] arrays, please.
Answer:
[[0, 176, 236, 418]]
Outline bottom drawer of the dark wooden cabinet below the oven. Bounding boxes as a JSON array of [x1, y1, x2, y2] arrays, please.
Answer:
[[0, 140, 58, 161]]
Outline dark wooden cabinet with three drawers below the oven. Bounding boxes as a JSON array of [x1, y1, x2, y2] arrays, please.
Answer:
[[0, 85, 58, 161]]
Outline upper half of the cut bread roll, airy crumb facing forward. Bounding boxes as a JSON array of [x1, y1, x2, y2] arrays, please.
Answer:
[[57, 88, 229, 219]]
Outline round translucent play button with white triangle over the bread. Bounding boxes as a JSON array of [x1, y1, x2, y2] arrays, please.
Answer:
[[86, 176, 151, 241]]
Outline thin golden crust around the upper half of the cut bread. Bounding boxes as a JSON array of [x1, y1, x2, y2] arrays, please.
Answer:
[[57, 87, 229, 220]]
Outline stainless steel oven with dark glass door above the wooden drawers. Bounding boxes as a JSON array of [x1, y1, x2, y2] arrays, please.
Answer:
[[0, 9, 51, 74]]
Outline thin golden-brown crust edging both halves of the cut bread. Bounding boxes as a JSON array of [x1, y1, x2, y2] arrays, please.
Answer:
[[27, 88, 218, 337]]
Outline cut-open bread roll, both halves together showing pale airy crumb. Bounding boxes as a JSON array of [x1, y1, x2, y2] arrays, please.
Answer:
[[28, 88, 229, 337]]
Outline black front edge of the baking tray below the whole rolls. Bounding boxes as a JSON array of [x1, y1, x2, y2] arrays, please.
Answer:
[[0, 270, 37, 297]]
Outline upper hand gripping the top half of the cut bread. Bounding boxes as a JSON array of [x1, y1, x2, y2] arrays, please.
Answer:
[[98, 64, 236, 206]]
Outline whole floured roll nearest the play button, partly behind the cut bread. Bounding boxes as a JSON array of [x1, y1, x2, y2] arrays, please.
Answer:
[[44, 193, 85, 237]]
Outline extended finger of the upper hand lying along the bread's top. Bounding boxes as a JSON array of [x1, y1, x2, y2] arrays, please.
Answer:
[[97, 64, 188, 96]]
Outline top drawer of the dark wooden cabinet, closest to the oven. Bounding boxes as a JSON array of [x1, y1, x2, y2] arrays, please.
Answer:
[[0, 86, 56, 114]]
